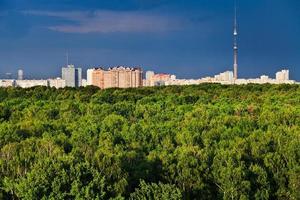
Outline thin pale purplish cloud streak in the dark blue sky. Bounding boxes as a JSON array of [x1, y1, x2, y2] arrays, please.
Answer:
[[23, 11, 185, 33]]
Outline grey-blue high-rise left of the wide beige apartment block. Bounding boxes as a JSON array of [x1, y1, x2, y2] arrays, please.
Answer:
[[62, 65, 82, 87]]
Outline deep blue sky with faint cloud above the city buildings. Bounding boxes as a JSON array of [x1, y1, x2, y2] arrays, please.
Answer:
[[0, 0, 300, 80]]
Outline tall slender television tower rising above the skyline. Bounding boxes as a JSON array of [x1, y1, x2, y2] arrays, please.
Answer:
[[233, 0, 238, 80]]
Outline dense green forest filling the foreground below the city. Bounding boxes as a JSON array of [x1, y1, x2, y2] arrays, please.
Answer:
[[0, 84, 300, 200]]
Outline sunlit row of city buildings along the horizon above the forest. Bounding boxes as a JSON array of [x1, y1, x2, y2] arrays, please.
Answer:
[[0, 65, 300, 89]]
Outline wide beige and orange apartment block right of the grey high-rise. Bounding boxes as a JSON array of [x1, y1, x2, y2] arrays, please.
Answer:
[[87, 66, 143, 89]]
